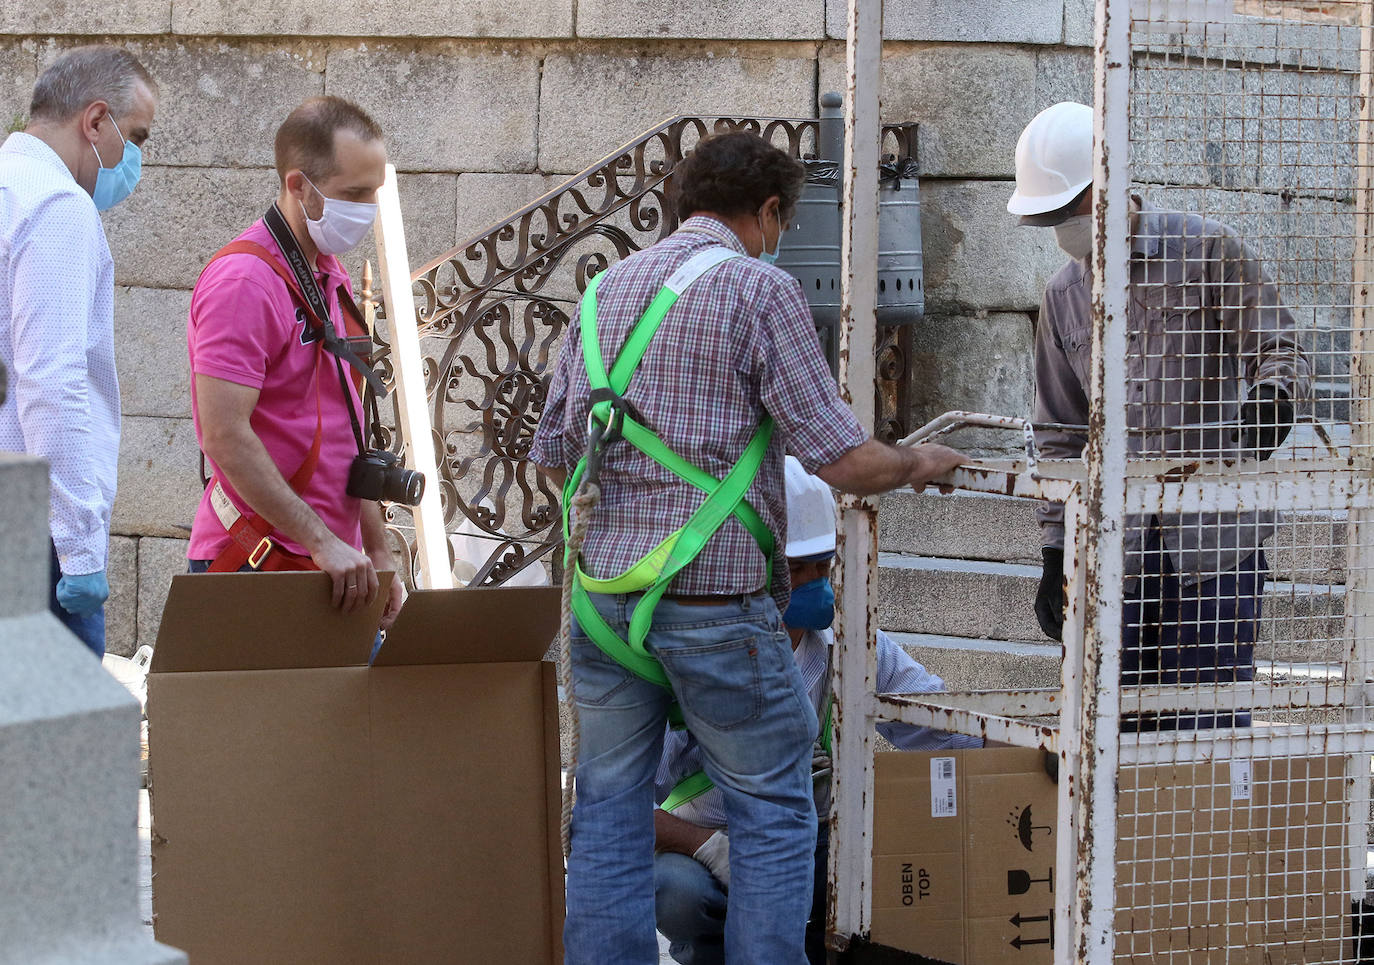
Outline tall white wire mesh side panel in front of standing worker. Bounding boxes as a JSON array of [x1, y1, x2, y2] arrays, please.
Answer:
[[1104, 0, 1374, 964]]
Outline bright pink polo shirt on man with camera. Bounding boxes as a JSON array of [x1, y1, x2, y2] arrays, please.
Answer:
[[185, 220, 365, 559]]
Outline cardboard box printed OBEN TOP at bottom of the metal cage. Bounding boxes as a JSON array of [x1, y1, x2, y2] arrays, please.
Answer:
[[872, 748, 1349, 965]]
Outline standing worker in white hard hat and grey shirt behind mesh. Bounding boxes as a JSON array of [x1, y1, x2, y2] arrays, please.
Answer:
[[1007, 103, 1311, 730]]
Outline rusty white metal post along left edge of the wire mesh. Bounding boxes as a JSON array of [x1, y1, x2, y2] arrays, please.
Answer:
[[1077, 0, 1131, 965]]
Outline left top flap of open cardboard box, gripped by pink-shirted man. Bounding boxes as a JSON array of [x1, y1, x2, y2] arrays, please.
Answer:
[[150, 573, 393, 674]]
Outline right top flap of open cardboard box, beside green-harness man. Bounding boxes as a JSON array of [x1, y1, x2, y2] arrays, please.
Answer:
[[372, 587, 559, 667]]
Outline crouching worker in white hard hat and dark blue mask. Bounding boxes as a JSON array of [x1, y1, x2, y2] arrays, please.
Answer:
[[654, 456, 982, 965]]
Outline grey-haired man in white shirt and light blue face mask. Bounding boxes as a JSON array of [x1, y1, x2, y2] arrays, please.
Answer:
[[0, 45, 157, 654]]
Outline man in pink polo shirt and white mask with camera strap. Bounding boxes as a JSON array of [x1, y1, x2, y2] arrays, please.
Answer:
[[187, 98, 405, 630]]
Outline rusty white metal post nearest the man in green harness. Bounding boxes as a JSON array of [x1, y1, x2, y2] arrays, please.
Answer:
[[827, 0, 882, 949]]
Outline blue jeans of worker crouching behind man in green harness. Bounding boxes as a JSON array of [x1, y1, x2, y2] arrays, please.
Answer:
[[654, 828, 830, 965]]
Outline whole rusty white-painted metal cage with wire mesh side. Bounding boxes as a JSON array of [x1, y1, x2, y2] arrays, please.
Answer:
[[831, 0, 1374, 964]]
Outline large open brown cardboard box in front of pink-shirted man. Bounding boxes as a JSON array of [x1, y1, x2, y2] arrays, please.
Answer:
[[148, 573, 563, 965]]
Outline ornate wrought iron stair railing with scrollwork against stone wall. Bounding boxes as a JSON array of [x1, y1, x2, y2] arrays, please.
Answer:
[[376, 110, 915, 584]]
